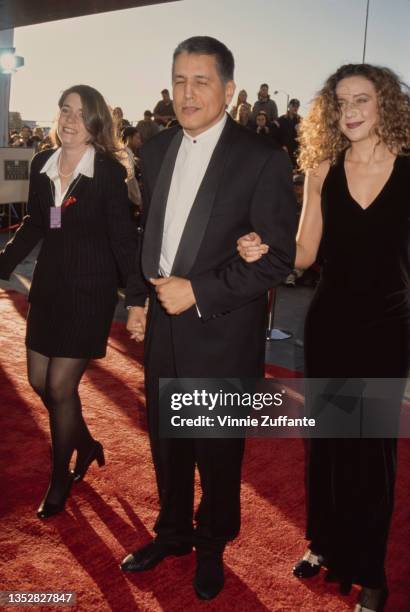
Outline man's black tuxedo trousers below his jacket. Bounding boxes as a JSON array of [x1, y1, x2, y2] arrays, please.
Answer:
[[145, 303, 245, 552]]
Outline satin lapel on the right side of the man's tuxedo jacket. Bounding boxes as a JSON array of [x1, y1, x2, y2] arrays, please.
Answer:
[[171, 117, 232, 277]]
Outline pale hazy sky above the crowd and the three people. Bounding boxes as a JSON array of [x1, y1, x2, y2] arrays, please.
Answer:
[[10, 0, 410, 124]]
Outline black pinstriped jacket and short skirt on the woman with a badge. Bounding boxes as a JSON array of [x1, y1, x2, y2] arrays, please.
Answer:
[[0, 150, 136, 358]]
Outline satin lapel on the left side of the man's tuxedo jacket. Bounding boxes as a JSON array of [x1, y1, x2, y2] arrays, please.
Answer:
[[141, 130, 183, 279]]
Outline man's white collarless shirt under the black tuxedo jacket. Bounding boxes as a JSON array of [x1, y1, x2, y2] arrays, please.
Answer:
[[159, 113, 226, 276]]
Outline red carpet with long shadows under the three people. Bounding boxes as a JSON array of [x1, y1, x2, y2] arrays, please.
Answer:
[[0, 291, 410, 612]]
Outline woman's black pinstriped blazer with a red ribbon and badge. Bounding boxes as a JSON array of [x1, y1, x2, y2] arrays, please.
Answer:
[[0, 150, 136, 302]]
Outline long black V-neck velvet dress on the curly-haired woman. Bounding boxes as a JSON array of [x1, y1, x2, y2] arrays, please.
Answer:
[[305, 148, 410, 588]]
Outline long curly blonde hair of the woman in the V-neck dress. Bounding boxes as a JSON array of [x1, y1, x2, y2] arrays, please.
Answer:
[[298, 64, 410, 171]]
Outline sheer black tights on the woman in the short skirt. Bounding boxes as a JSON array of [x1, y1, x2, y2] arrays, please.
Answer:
[[27, 349, 93, 504]]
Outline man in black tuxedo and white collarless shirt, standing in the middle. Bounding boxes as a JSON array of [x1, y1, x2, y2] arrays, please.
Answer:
[[121, 36, 296, 599]]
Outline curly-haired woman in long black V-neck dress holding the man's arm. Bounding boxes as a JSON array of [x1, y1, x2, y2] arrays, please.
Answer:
[[239, 64, 410, 611]]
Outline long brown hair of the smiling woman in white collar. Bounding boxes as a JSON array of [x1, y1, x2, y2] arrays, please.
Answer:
[[54, 85, 120, 160]]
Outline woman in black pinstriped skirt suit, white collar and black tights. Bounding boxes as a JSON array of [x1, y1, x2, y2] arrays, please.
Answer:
[[0, 85, 136, 518]]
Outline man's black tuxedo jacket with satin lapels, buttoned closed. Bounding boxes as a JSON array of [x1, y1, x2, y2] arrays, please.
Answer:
[[126, 112, 296, 377]]
